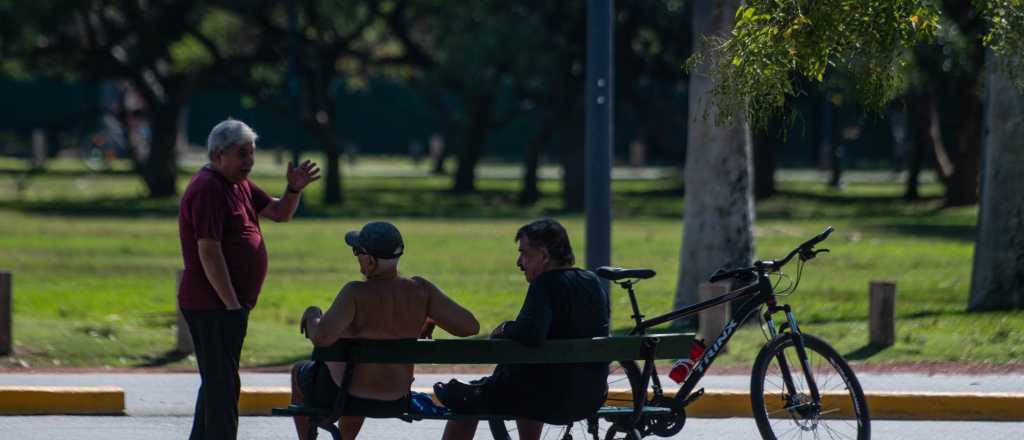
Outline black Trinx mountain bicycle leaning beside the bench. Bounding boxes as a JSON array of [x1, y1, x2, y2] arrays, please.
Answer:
[[493, 227, 870, 440]]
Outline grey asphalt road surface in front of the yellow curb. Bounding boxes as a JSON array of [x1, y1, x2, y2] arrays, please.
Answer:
[[0, 415, 1024, 440]]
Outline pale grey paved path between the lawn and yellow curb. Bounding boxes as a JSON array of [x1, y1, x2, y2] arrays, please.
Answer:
[[0, 372, 1024, 415]]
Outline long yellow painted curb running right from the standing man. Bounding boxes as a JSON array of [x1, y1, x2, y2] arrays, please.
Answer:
[[239, 387, 1024, 422]]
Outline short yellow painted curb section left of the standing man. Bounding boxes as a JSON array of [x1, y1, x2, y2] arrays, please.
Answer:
[[0, 386, 125, 415]]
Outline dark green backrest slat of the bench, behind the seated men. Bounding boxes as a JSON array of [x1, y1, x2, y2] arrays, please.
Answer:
[[312, 334, 693, 364]]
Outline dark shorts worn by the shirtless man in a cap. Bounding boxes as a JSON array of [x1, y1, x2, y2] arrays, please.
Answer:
[[298, 360, 409, 417]]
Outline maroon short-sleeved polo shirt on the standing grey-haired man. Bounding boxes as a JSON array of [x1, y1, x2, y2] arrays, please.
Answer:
[[178, 168, 270, 310]]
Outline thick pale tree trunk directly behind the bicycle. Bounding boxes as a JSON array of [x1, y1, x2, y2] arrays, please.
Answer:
[[675, 0, 754, 308]]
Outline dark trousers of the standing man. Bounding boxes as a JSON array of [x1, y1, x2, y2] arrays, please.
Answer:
[[181, 309, 249, 440]]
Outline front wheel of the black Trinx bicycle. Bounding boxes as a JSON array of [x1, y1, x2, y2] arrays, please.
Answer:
[[751, 334, 871, 440]]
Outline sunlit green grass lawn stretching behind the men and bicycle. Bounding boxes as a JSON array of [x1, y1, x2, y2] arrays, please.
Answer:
[[0, 156, 1024, 367]]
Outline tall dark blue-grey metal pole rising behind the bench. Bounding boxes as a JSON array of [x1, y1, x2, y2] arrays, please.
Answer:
[[584, 0, 615, 274]]
